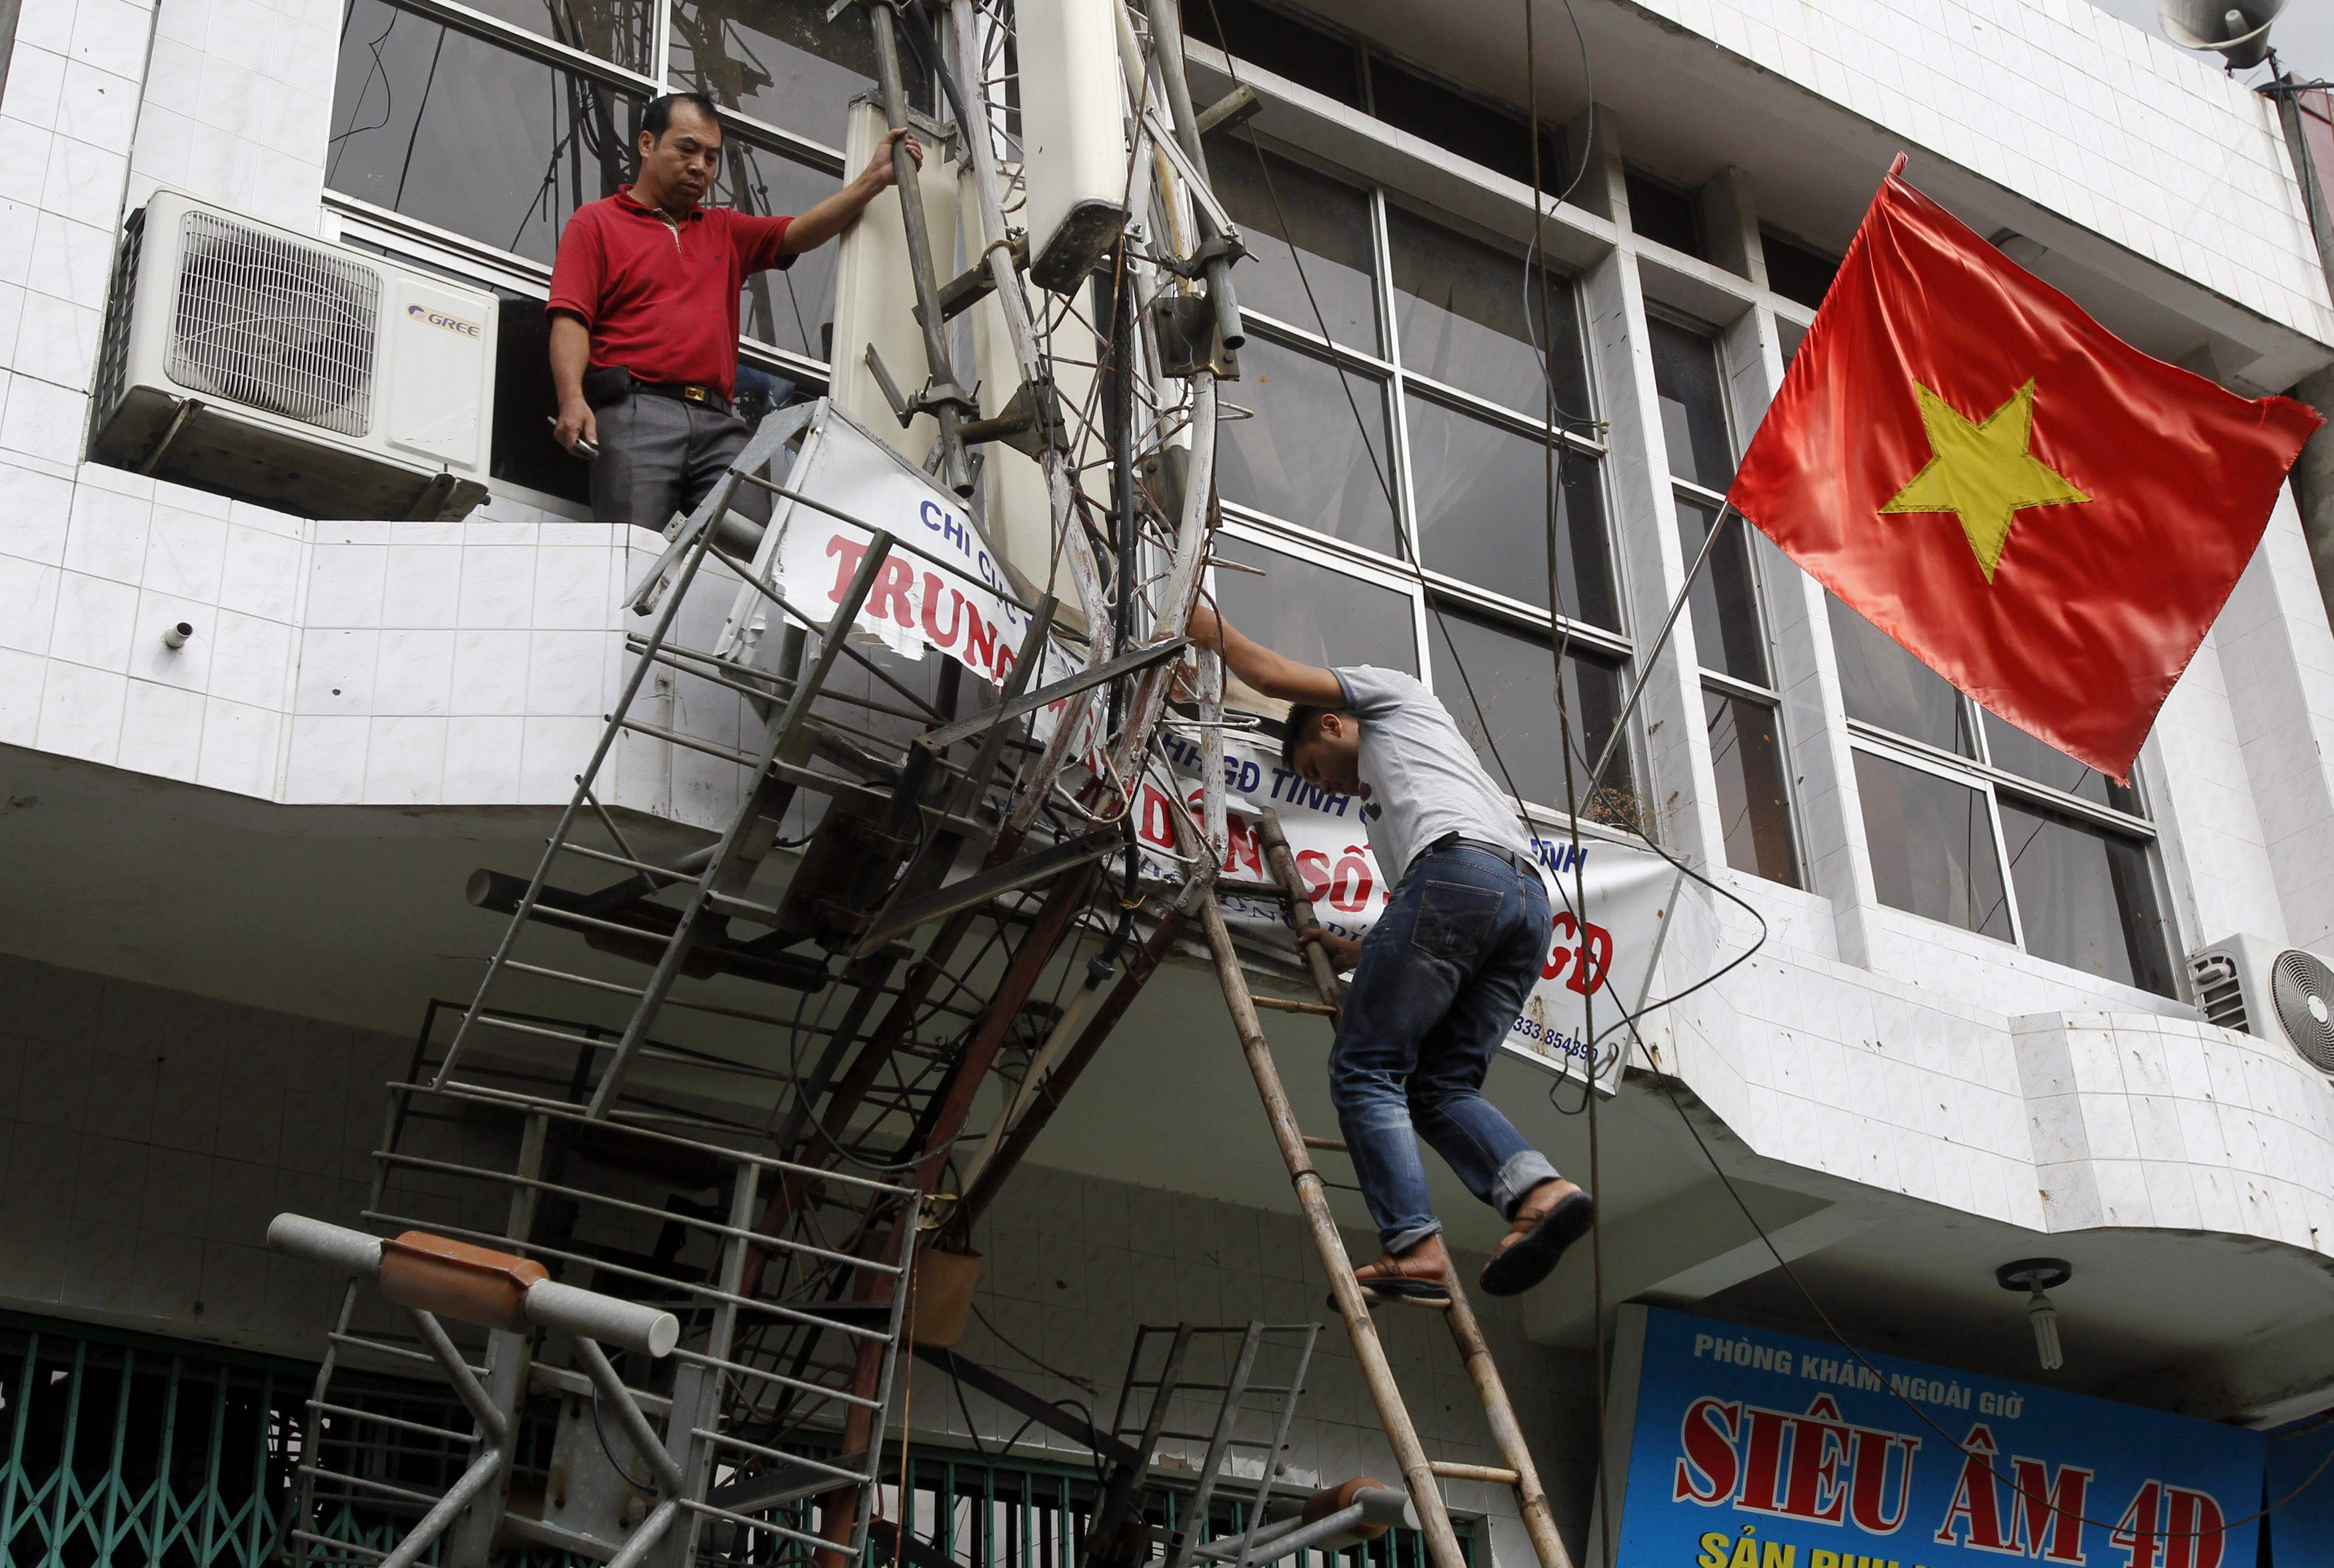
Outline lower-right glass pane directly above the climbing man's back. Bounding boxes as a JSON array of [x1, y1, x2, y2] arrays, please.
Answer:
[[1426, 605, 1652, 833]]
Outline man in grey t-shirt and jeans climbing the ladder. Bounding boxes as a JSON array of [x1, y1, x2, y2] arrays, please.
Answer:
[[1190, 605, 1594, 1297]]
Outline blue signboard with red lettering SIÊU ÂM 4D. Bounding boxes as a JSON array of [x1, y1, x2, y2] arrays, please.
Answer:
[[1618, 1309, 2285, 1568]]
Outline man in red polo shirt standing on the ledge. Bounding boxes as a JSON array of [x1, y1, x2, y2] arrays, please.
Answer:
[[546, 93, 924, 530]]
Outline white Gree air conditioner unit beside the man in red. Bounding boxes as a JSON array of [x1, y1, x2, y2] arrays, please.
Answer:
[[91, 191, 497, 521]]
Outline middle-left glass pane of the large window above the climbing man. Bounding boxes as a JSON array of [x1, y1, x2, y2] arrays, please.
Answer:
[[1218, 339, 1398, 553]]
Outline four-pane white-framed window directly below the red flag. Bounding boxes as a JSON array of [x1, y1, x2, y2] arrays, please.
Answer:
[[1828, 600, 2180, 997]]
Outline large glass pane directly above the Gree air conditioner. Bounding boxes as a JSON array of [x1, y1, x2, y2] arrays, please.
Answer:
[[325, 0, 642, 261]]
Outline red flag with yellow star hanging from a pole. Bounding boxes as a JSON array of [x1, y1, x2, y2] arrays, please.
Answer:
[[1727, 159, 2323, 779]]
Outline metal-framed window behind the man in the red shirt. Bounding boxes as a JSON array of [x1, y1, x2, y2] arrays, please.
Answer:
[[325, 0, 878, 502]]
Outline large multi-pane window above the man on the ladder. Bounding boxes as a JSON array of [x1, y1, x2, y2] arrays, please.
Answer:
[[1209, 131, 1634, 819]]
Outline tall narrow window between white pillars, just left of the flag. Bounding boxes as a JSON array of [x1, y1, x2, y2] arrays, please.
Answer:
[[1646, 313, 1800, 887]]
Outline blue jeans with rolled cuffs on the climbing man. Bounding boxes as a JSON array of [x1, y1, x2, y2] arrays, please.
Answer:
[[1328, 843, 1557, 1253]]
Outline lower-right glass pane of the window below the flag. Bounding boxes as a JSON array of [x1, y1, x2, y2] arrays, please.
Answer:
[[2003, 798, 2178, 997]]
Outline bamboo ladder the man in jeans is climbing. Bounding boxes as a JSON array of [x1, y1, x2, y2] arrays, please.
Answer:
[[1200, 810, 1573, 1568]]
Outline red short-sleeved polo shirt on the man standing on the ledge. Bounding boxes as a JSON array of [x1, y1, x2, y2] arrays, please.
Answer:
[[544, 191, 794, 397]]
